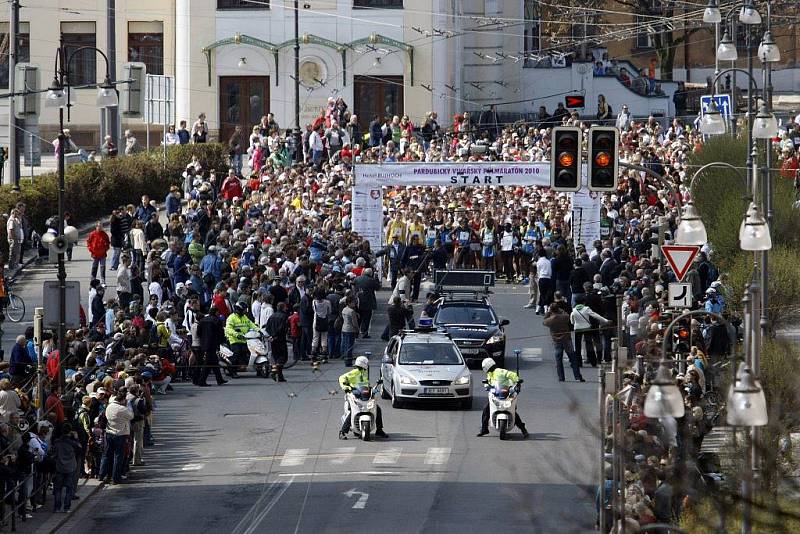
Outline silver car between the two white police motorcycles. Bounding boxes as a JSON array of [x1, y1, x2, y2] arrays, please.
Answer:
[[381, 331, 472, 409]]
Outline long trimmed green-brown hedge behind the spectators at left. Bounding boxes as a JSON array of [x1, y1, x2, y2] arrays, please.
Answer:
[[0, 143, 228, 262]]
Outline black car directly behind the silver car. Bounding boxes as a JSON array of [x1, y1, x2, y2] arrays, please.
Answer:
[[433, 299, 508, 367]]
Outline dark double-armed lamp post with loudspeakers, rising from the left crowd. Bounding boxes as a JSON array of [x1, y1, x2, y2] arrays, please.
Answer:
[[45, 39, 119, 387]]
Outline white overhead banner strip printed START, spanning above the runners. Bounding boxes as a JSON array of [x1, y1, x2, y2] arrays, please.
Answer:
[[353, 161, 550, 187]]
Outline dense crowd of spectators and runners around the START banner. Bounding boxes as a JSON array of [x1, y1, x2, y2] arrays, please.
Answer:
[[0, 88, 800, 523]]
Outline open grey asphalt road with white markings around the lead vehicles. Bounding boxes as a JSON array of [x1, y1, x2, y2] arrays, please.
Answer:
[[48, 280, 599, 534]]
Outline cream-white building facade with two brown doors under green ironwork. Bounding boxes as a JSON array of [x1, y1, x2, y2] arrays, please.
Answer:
[[176, 0, 458, 140]]
